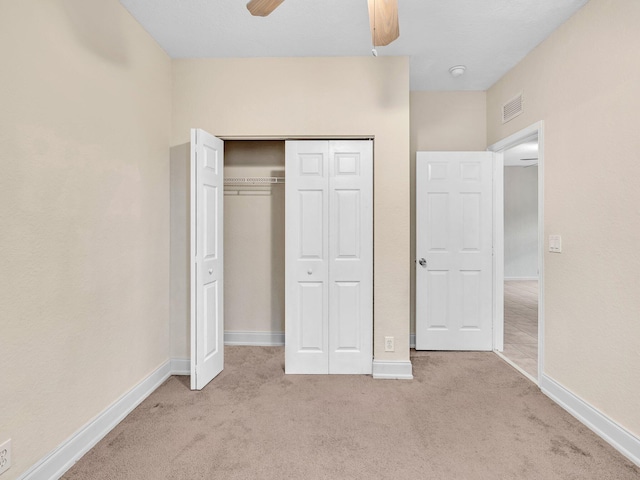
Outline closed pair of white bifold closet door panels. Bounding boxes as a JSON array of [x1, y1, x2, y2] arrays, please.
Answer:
[[285, 140, 373, 374]]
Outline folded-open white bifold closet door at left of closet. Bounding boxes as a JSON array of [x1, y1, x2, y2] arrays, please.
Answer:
[[190, 129, 224, 390]]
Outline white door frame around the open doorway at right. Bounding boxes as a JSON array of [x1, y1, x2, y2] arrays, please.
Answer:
[[487, 121, 545, 383]]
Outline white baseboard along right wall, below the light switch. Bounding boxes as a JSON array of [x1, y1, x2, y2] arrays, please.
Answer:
[[539, 375, 640, 466]]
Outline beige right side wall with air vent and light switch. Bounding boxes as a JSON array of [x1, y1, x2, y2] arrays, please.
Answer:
[[487, 0, 640, 436]]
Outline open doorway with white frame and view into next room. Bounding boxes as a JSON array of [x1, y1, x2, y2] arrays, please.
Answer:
[[489, 122, 544, 383]]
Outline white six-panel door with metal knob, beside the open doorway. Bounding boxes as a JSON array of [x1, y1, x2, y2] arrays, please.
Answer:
[[416, 152, 493, 350]]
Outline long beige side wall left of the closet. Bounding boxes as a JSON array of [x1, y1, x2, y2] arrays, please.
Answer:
[[0, 0, 171, 480]]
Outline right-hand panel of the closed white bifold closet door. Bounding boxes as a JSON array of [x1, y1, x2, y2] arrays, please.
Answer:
[[328, 140, 373, 374]]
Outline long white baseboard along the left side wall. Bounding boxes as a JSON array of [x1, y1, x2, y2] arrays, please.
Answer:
[[19, 360, 171, 480]]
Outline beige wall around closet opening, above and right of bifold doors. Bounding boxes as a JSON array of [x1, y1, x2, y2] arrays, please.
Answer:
[[172, 57, 409, 360]]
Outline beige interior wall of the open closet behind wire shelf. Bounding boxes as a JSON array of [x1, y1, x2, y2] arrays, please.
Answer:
[[224, 140, 285, 338]]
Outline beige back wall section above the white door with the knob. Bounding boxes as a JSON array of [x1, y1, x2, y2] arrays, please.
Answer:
[[410, 92, 487, 333]]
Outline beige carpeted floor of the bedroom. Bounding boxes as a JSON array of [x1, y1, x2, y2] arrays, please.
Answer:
[[63, 347, 640, 480]]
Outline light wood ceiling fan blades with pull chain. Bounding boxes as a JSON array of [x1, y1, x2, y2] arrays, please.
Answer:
[[247, 0, 400, 47]]
